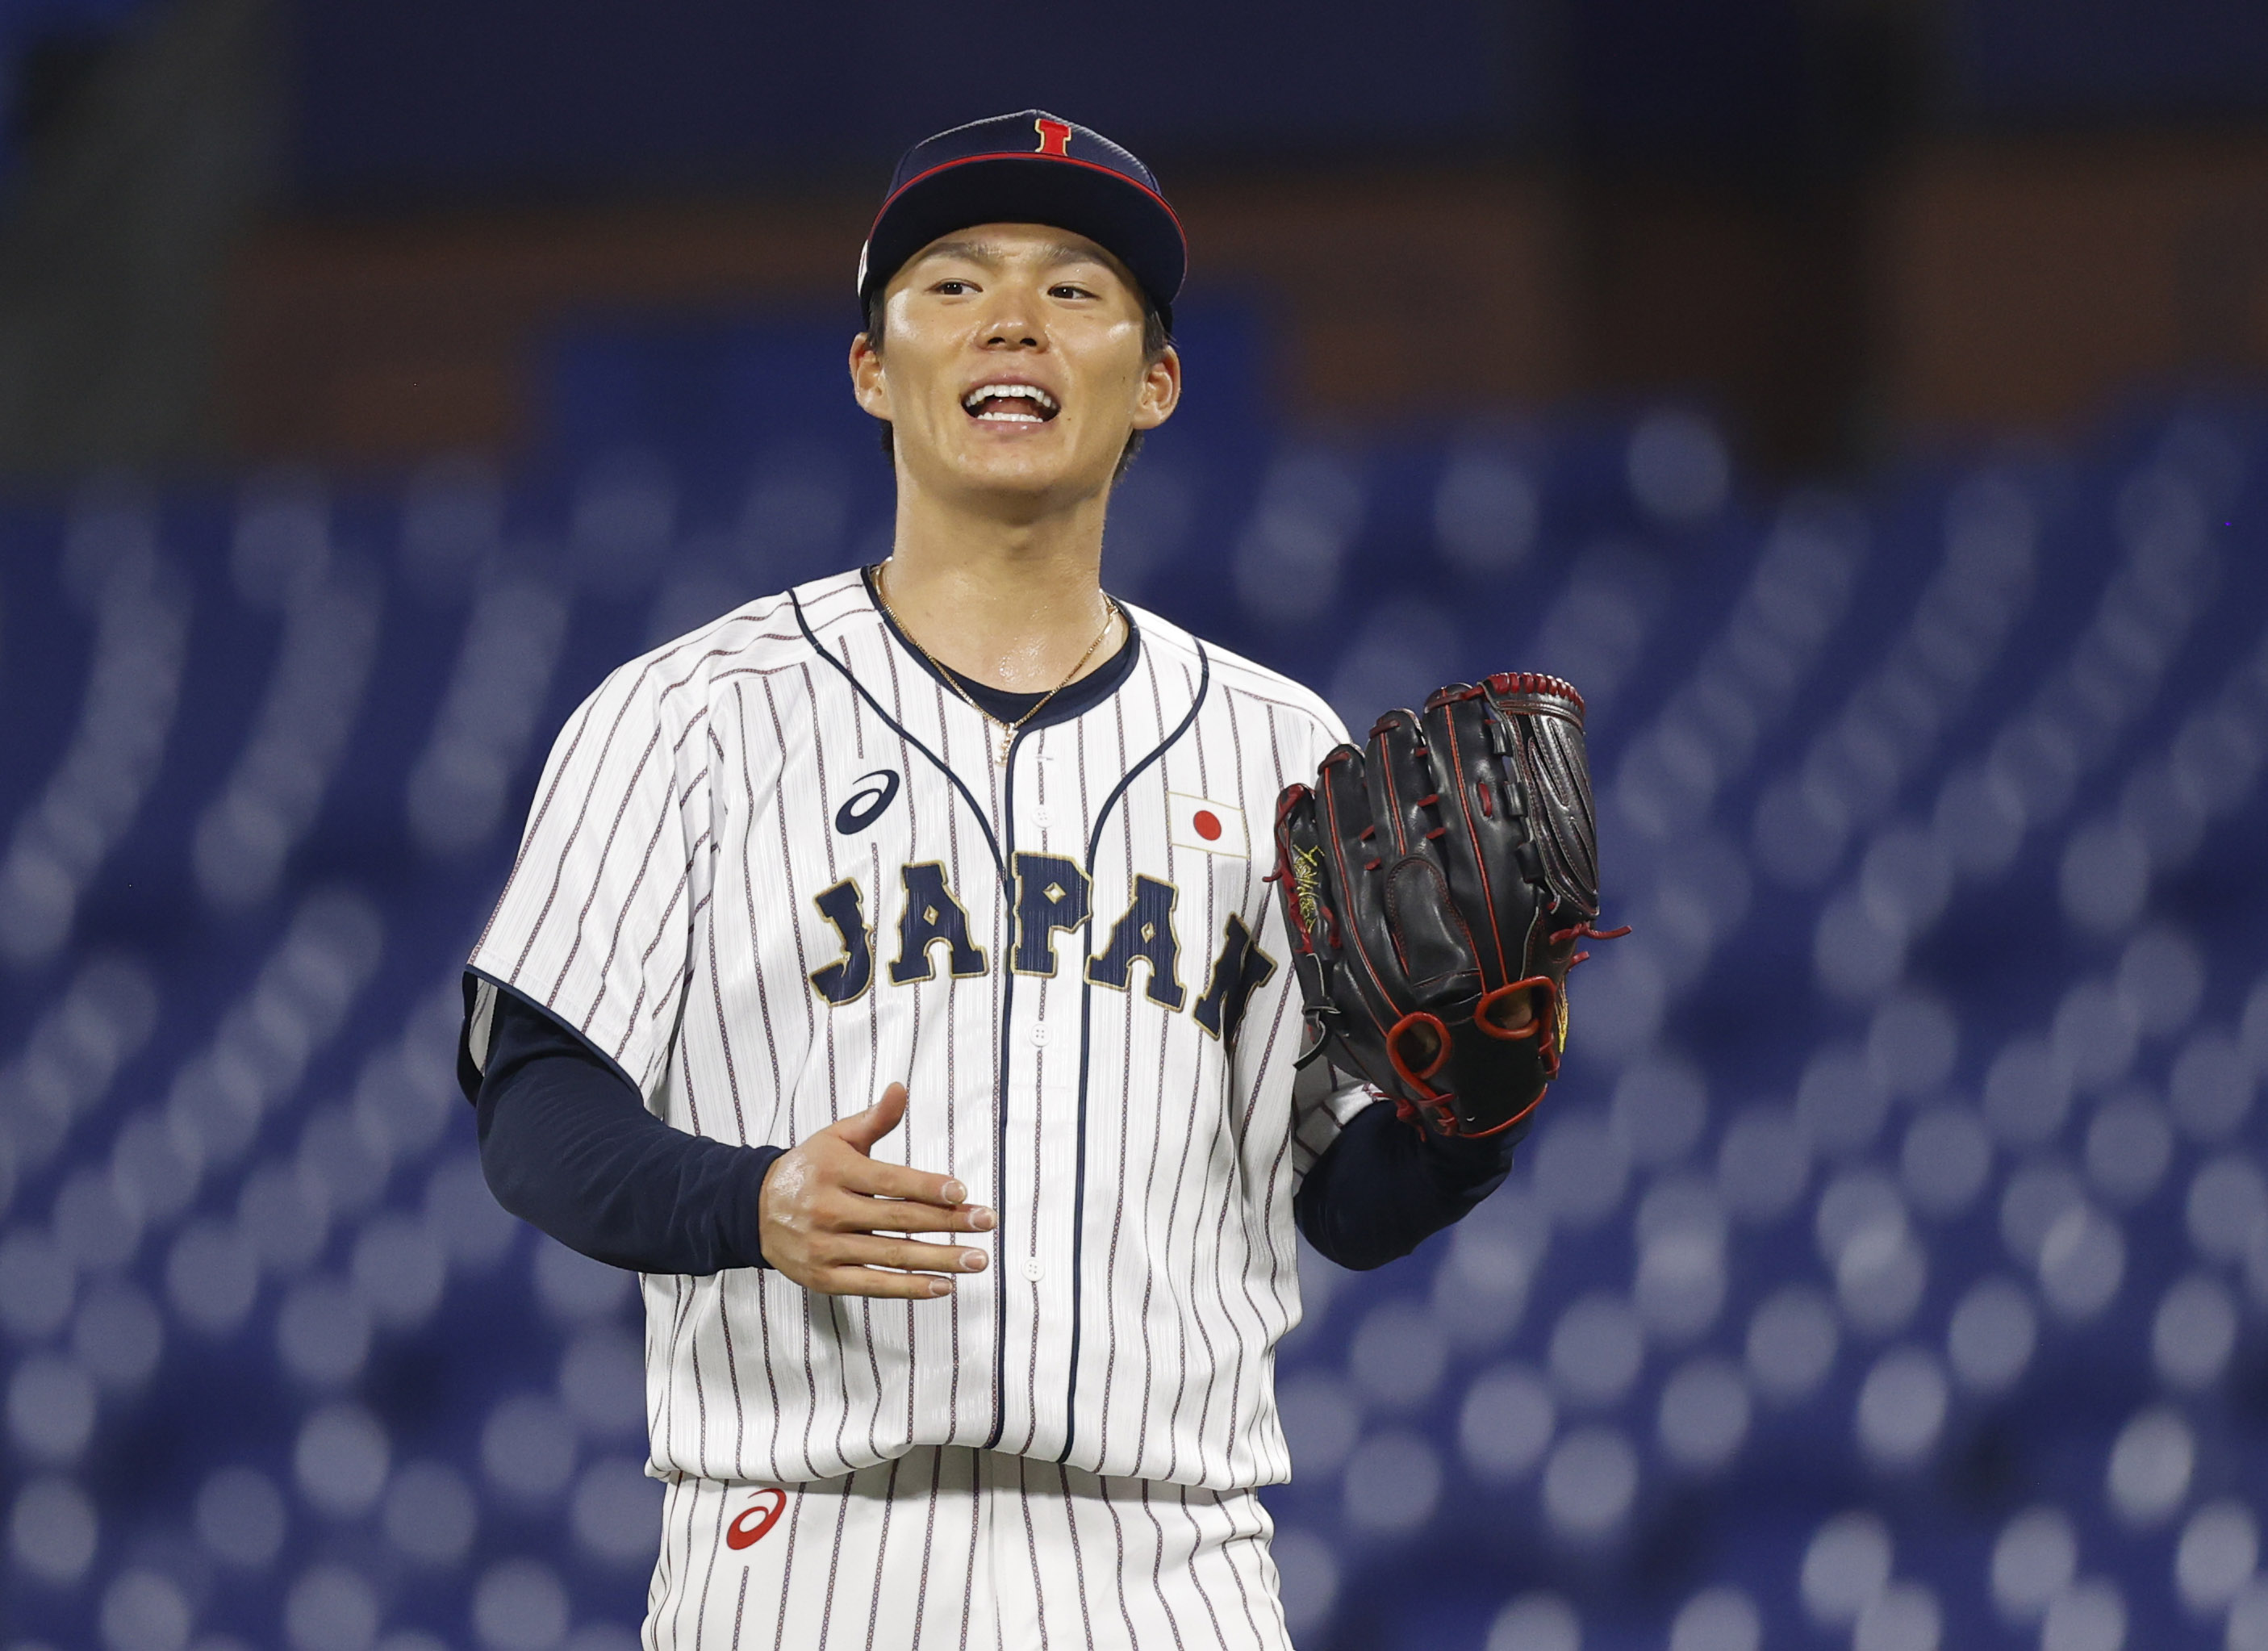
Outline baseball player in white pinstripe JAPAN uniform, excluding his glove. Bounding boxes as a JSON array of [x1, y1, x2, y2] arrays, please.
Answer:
[[461, 111, 1596, 1651]]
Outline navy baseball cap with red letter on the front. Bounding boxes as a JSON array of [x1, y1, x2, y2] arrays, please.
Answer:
[[858, 109, 1188, 329]]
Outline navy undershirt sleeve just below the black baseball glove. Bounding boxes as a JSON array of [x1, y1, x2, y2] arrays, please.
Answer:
[[1290, 1100, 1522, 1273]]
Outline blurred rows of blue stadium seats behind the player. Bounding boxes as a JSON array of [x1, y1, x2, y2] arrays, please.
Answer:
[[0, 365, 2268, 1651]]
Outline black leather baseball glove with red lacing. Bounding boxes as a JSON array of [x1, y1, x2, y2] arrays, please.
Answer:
[[1272, 671, 1626, 1136]]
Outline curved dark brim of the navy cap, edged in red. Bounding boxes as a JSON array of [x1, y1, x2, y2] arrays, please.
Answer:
[[859, 154, 1188, 327]]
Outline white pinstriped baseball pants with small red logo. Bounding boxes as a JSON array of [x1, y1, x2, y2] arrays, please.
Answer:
[[644, 1444, 1290, 1651]]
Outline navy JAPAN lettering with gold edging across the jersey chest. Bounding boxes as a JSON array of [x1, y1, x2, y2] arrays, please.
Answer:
[[812, 857, 1277, 1039]]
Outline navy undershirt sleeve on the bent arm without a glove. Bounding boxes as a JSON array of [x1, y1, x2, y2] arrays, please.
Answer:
[[472, 991, 785, 1274]]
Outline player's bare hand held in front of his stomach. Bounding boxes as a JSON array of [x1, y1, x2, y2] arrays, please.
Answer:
[[758, 1084, 998, 1299]]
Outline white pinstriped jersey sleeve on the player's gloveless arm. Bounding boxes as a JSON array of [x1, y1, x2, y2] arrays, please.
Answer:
[[465, 662, 705, 1102]]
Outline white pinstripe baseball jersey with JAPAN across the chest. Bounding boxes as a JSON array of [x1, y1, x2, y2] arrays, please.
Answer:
[[472, 574, 1370, 1490]]
